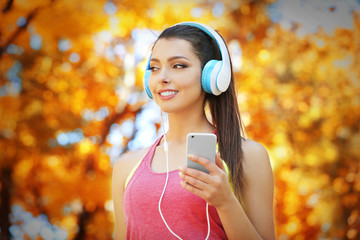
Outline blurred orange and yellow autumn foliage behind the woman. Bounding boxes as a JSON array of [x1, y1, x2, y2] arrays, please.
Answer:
[[0, 0, 360, 239]]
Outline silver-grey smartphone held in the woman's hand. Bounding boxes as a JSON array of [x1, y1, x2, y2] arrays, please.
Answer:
[[186, 133, 216, 173]]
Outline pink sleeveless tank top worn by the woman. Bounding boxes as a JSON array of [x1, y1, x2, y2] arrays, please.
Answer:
[[123, 137, 227, 240]]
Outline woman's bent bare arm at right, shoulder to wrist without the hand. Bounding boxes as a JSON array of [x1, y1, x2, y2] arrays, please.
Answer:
[[217, 140, 275, 239]]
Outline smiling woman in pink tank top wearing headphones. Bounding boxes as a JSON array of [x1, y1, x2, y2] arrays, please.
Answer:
[[113, 22, 275, 239]]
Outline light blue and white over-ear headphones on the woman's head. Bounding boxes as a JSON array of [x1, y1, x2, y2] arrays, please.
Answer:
[[144, 22, 231, 99]]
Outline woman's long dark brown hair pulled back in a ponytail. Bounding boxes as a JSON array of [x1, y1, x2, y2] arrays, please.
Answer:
[[158, 25, 245, 202]]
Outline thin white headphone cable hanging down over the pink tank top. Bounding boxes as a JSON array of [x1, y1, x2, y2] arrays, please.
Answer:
[[158, 111, 210, 240]]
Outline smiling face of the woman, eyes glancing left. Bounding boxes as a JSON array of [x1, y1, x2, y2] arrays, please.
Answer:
[[149, 38, 205, 113]]
